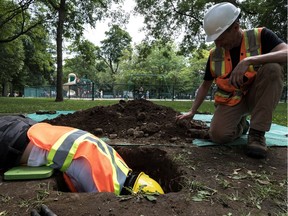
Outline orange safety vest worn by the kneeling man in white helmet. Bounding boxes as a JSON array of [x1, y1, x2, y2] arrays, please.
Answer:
[[210, 28, 262, 106]]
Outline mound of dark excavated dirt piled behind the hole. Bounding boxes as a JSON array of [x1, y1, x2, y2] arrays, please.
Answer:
[[46, 99, 208, 144]]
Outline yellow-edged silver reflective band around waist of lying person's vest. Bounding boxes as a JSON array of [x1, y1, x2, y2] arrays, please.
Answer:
[[47, 129, 87, 172]]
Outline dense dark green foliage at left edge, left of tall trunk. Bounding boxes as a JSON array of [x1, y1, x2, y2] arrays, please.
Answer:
[[0, 26, 55, 95]]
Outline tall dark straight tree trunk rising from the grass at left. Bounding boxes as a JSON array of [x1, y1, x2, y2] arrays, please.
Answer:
[[56, 0, 66, 102]]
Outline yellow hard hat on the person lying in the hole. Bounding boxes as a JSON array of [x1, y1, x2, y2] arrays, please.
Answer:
[[132, 172, 164, 194]]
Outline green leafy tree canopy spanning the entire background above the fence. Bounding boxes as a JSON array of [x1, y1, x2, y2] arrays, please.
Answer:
[[0, 0, 287, 101]]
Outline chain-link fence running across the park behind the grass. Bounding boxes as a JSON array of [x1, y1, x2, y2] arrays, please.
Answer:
[[23, 83, 288, 102]]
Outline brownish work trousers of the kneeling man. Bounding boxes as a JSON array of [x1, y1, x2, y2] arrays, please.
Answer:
[[209, 63, 283, 144]]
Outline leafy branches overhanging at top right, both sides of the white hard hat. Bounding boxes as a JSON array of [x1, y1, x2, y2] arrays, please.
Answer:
[[135, 0, 287, 53]]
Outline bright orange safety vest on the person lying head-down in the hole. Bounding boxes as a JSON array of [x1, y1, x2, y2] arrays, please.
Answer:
[[27, 123, 130, 195]]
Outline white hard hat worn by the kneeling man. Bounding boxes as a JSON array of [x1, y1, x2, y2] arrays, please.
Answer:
[[203, 2, 241, 42]]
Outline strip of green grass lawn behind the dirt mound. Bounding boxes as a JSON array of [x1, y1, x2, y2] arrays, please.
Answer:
[[0, 97, 287, 126]]
